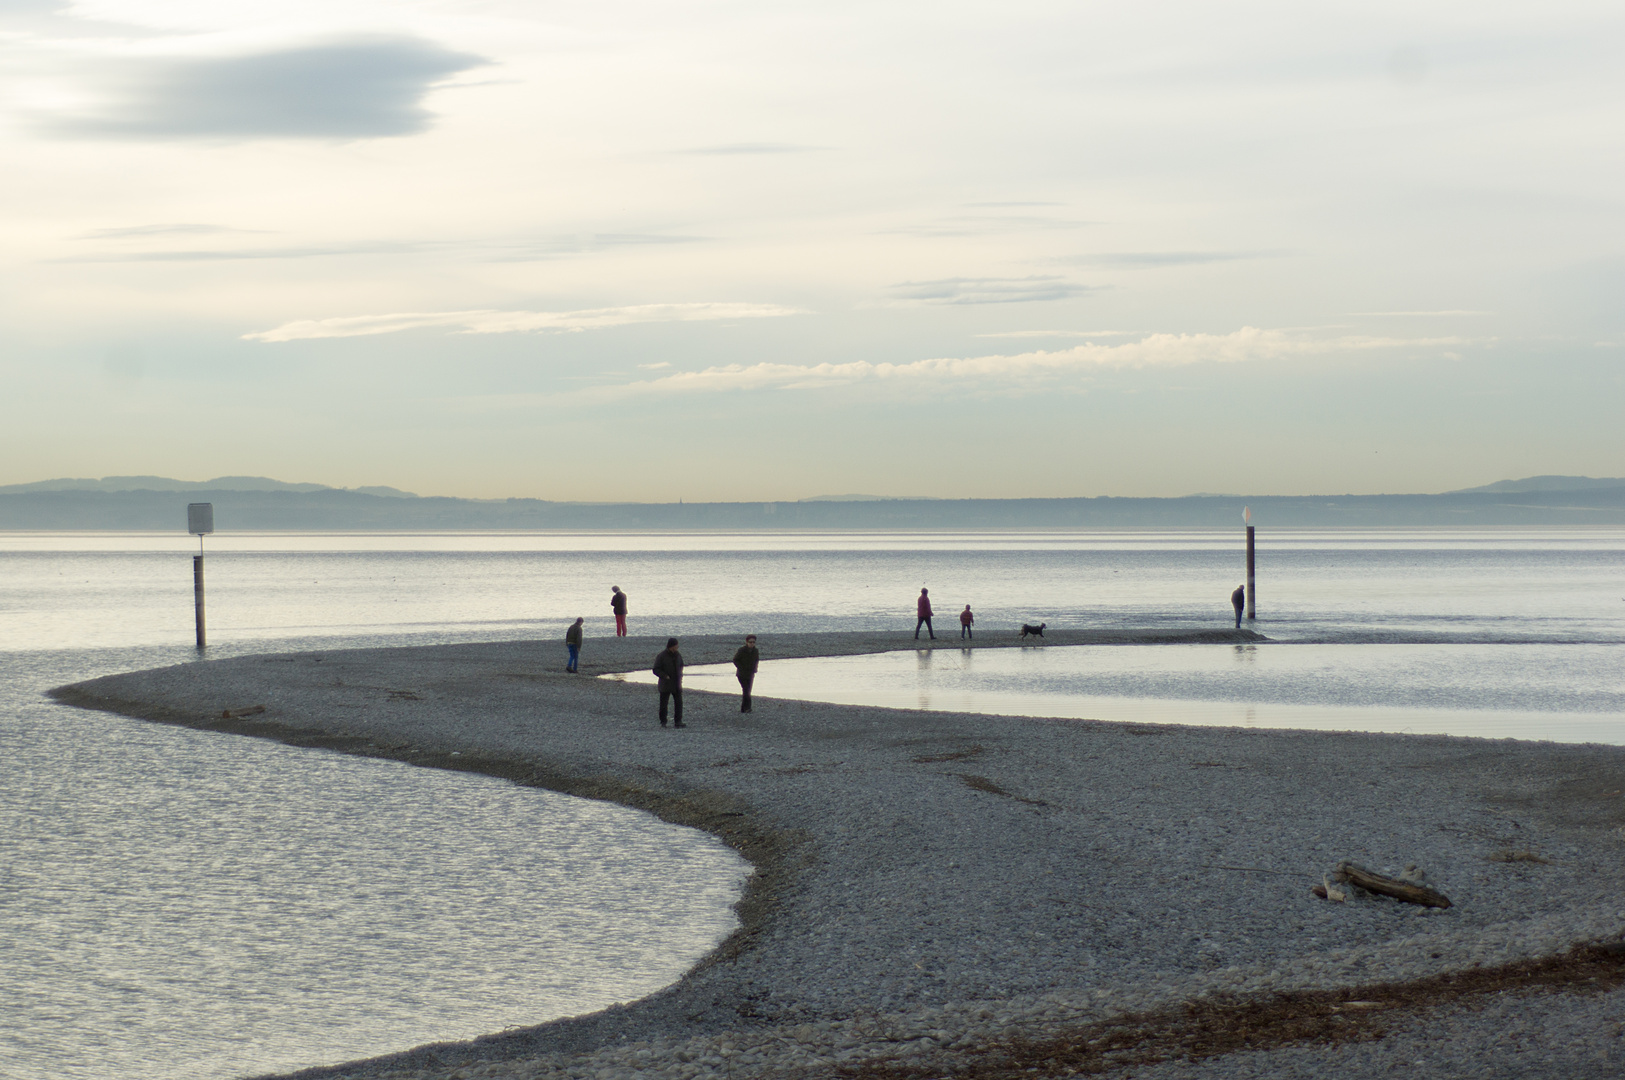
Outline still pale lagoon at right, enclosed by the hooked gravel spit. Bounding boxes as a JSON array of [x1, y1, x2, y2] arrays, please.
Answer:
[[629, 643, 1625, 745]]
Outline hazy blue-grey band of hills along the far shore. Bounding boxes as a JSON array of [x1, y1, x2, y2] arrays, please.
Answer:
[[0, 477, 1625, 534]]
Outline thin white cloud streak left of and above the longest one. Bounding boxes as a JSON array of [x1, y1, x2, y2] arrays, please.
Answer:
[[242, 304, 806, 341]]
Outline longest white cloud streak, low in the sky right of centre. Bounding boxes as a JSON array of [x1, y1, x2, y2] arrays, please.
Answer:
[[613, 326, 1467, 393]]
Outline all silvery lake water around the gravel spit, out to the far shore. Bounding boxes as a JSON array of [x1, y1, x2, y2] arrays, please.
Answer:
[[0, 523, 1625, 1080]]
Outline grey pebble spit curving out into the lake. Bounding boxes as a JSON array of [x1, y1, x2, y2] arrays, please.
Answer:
[[52, 630, 1625, 1077]]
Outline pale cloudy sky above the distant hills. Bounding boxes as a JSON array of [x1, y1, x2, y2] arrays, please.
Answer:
[[0, 0, 1625, 502]]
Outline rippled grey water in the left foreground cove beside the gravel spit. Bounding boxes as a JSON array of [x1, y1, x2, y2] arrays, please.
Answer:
[[0, 639, 748, 1080]]
